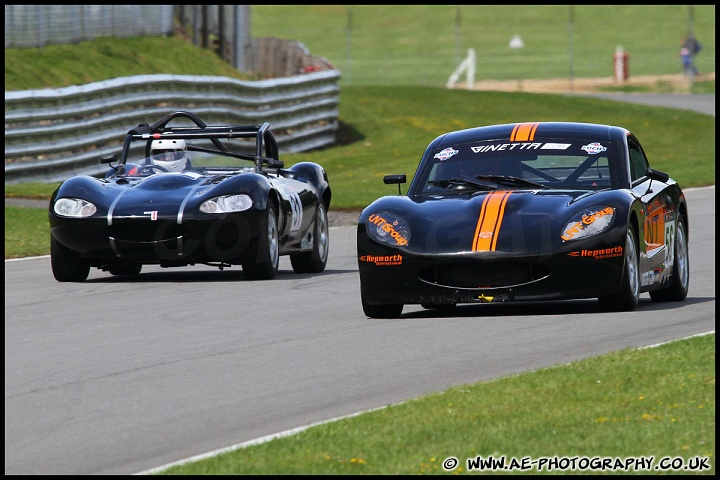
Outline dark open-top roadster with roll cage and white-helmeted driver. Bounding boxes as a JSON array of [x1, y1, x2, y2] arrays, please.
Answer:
[[49, 111, 331, 282]]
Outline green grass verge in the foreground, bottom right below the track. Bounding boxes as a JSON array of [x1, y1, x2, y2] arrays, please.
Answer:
[[153, 334, 715, 475]]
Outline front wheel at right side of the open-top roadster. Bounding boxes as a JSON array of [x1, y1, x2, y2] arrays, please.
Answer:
[[243, 203, 280, 280]]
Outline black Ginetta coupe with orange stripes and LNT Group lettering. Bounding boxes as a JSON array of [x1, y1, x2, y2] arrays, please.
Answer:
[[357, 122, 690, 318]]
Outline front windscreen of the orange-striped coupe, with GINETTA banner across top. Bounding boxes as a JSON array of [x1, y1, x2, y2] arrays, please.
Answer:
[[416, 138, 617, 194]]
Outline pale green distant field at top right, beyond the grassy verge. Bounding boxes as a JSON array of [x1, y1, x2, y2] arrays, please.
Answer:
[[251, 5, 715, 87]]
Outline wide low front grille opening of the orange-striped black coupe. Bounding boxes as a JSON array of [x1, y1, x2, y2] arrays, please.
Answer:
[[418, 262, 550, 288]]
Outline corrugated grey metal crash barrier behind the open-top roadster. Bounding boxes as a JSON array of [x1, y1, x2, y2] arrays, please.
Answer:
[[5, 70, 340, 183]]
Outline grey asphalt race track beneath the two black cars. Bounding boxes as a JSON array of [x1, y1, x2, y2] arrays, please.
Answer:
[[5, 92, 715, 475]]
